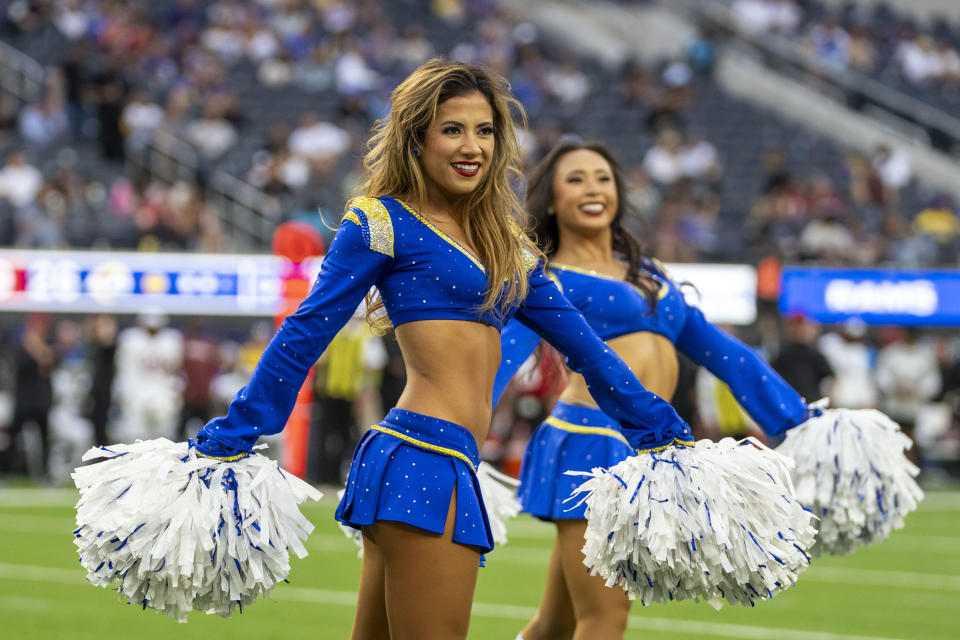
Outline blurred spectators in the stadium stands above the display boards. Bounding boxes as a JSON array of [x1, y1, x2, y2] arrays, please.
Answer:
[[0, 0, 960, 266]]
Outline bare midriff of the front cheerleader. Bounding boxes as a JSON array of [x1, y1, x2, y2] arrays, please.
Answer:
[[396, 320, 500, 443]]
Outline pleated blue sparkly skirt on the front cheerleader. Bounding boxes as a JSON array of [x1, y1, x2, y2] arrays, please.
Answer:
[[336, 409, 493, 553]]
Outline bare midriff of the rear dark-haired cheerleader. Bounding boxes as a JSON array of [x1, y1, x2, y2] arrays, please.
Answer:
[[559, 331, 677, 407]]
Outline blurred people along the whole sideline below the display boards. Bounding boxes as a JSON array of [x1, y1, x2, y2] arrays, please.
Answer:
[[0, 309, 960, 484]]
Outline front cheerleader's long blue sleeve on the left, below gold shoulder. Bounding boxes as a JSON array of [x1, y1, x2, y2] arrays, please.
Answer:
[[196, 220, 391, 457]]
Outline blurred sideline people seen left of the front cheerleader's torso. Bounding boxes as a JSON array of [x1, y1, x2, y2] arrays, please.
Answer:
[[0, 308, 404, 484]]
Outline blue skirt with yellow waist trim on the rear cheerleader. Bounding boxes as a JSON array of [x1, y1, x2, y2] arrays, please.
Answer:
[[517, 402, 633, 520]]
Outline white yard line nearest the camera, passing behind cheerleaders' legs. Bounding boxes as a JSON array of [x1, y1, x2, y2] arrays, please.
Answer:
[[0, 564, 895, 640]]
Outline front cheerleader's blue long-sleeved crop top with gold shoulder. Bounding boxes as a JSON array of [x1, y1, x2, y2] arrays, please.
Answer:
[[194, 196, 692, 458]]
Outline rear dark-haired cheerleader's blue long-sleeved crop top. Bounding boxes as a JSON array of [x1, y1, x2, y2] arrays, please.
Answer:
[[493, 261, 815, 435]]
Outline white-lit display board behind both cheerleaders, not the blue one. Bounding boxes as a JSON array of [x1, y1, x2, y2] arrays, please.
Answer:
[[0, 250, 757, 324]]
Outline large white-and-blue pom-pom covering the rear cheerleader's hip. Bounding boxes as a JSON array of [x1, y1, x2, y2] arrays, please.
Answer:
[[568, 438, 816, 608]]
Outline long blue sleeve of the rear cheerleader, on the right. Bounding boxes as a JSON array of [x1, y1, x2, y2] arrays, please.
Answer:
[[676, 306, 813, 435]]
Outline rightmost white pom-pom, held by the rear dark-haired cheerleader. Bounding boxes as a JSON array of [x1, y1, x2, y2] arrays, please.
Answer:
[[777, 409, 923, 554]]
